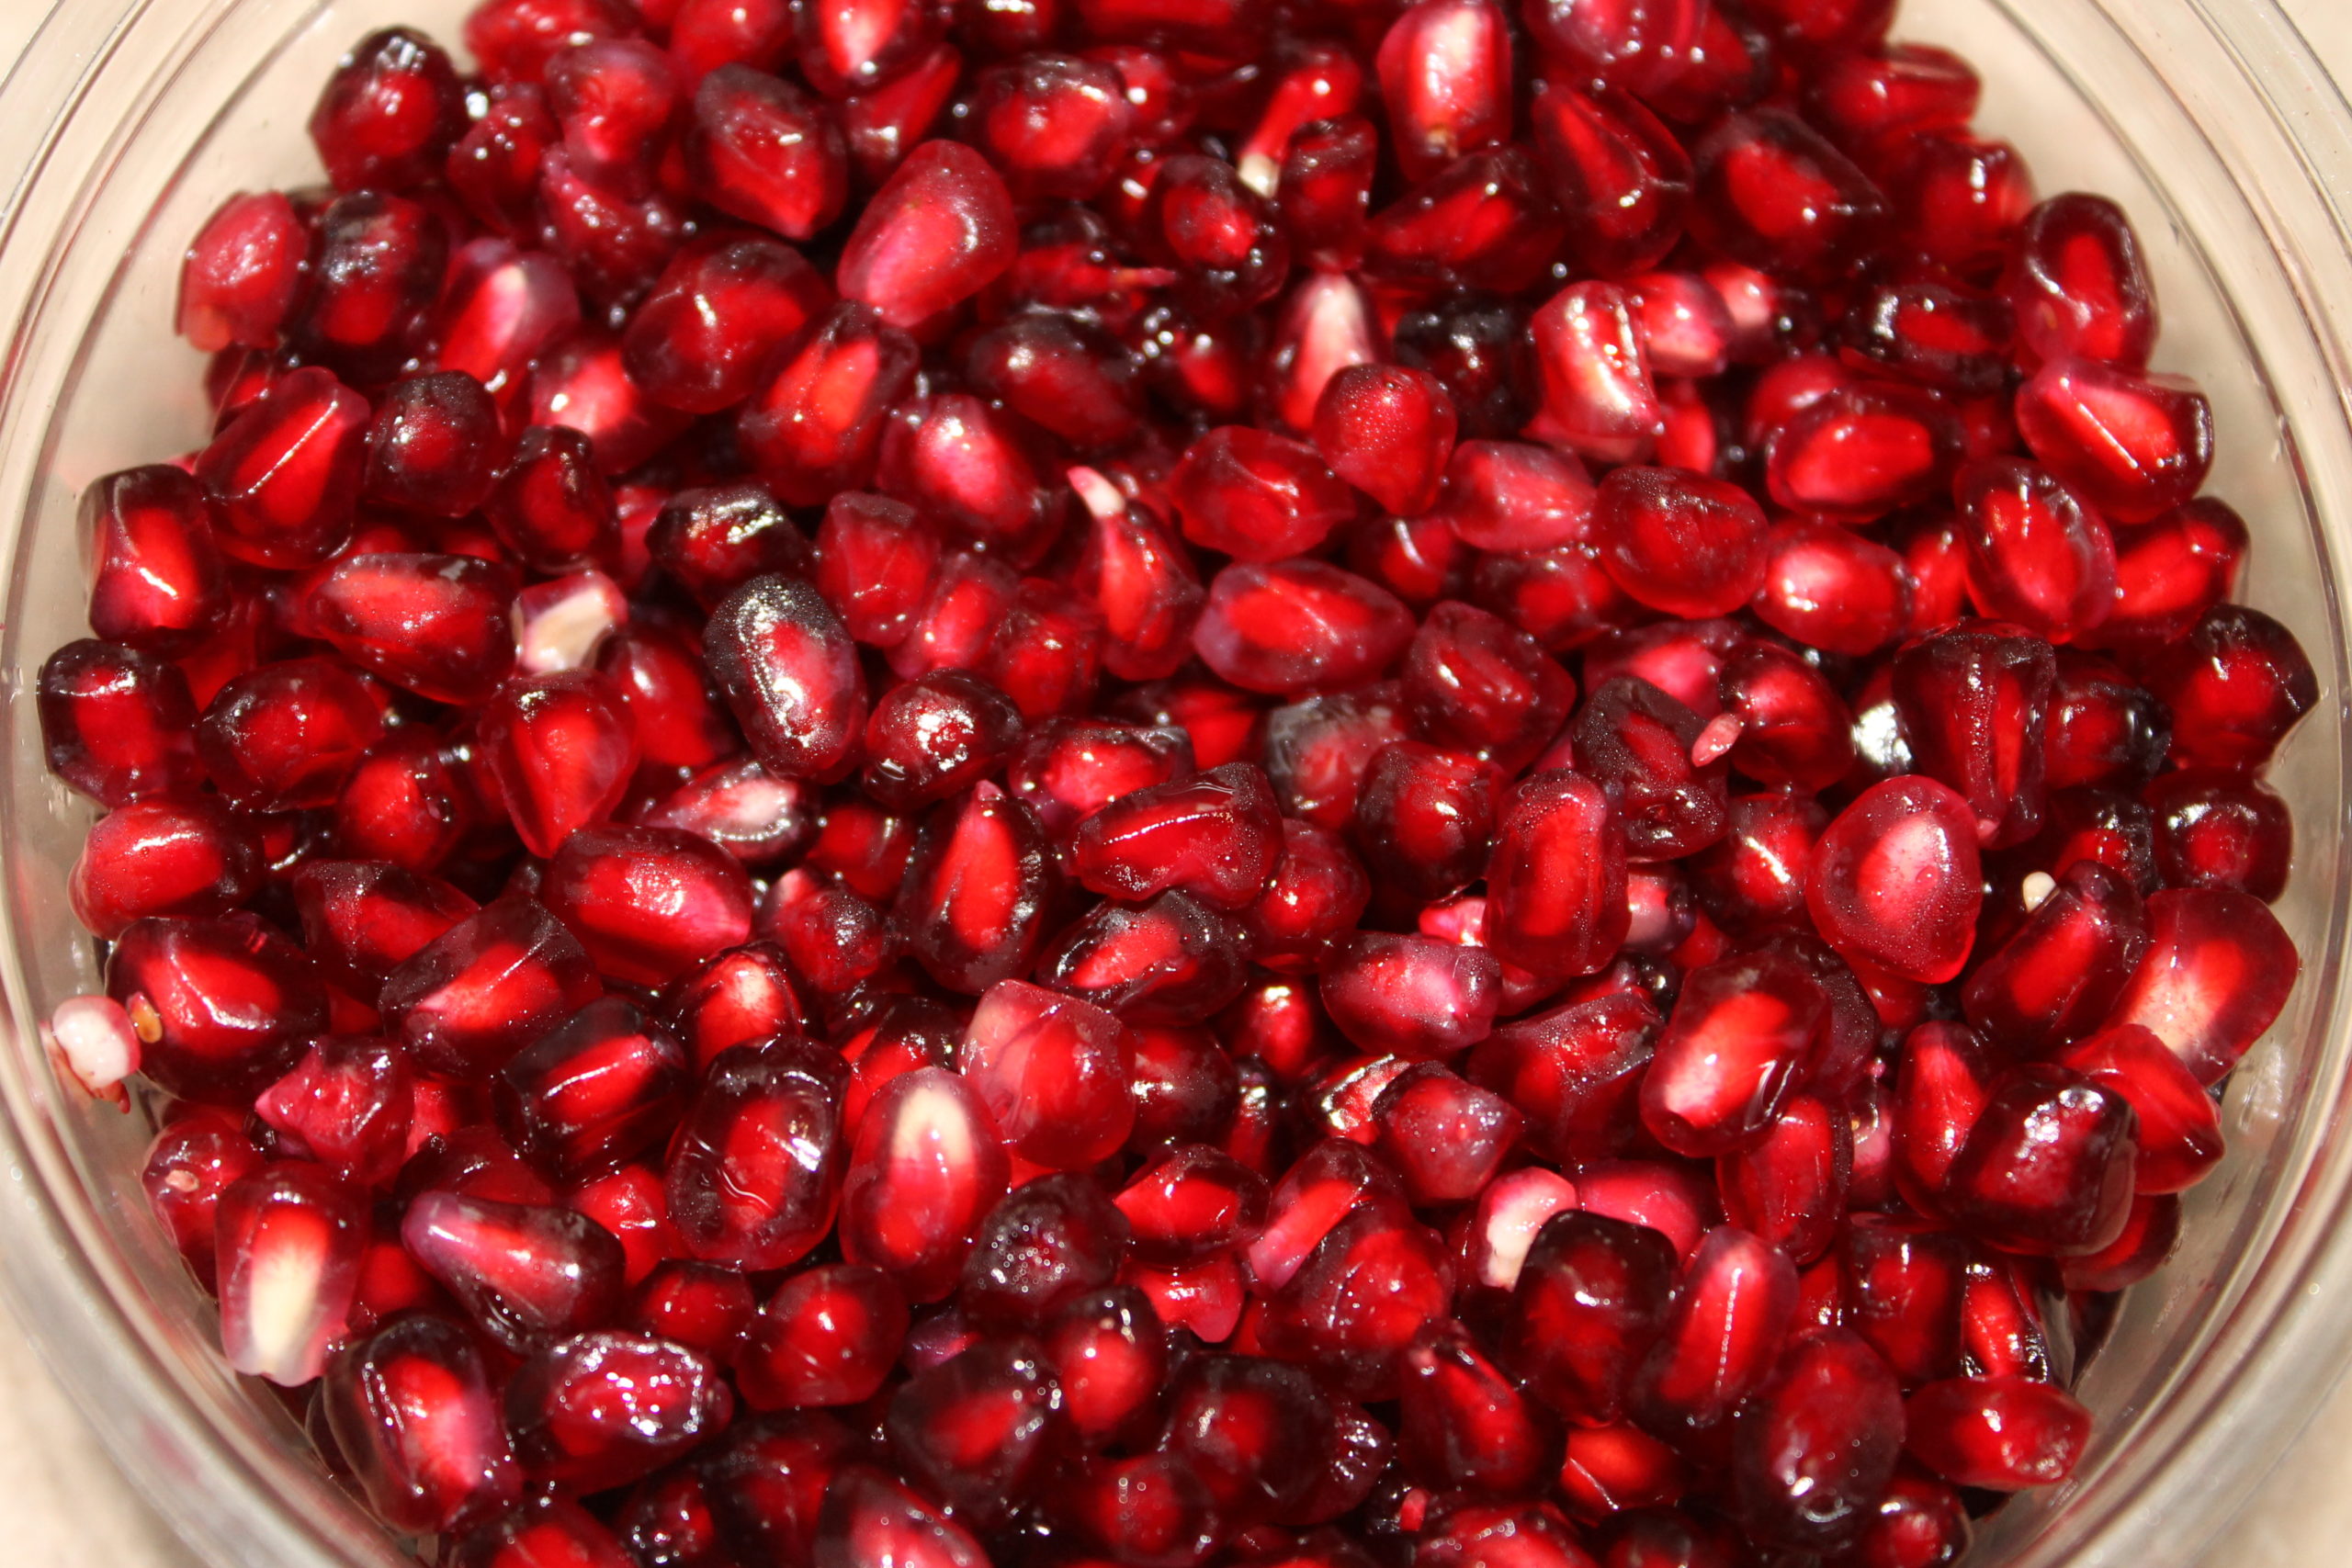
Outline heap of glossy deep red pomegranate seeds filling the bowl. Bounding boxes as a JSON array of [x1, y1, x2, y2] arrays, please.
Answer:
[[40, 0, 2317, 1568]]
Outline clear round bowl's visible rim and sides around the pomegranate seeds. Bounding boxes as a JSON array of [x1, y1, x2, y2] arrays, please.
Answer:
[[0, 0, 2352, 1568]]
